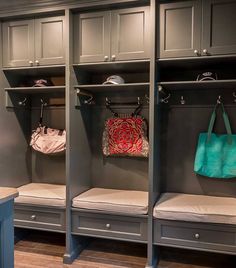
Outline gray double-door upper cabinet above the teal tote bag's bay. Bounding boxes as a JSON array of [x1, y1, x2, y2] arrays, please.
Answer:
[[160, 0, 236, 58]]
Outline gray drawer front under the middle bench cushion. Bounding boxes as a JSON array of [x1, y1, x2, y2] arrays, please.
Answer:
[[72, 212, 147, 241]]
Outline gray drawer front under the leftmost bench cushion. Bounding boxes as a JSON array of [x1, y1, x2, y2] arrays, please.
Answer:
[[14, 207, 65, 231]]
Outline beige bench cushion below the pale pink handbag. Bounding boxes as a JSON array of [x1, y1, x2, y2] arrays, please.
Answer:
[[15, 183, 66, 207]]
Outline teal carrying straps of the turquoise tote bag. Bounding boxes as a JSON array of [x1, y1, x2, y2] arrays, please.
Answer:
[[207, 103, 232, 143]]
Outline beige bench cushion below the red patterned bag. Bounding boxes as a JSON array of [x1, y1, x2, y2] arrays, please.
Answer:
[[72, 188, 148, 215]]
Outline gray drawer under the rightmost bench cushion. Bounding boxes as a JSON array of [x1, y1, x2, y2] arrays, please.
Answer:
[[154, 219, 236, 255]]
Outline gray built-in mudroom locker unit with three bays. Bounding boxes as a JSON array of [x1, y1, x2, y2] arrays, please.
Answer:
[[0, 0, 236, 268]]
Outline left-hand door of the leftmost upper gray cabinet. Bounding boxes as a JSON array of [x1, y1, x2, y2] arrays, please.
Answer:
[[2, 20, 34, 67]]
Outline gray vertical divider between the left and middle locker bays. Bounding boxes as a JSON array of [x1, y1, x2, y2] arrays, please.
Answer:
[[63, 10, 91, 263]]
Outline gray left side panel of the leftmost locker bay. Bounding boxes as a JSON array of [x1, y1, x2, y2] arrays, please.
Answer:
[[0, 28, 31, 187]]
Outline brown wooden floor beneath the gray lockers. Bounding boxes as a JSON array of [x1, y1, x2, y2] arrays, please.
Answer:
[[15, 231, 236, 268]]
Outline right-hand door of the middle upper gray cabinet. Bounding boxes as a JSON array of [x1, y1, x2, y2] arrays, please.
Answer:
[[111, 7, 150, 60]]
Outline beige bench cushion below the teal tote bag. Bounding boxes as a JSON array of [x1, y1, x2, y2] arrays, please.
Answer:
[[153, 193, 236, 224]]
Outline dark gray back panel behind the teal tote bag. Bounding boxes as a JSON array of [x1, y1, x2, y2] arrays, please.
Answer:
[[161, 105, 236, 197]]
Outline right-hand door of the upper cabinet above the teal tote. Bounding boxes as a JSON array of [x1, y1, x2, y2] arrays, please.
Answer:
[[202, 0, 236, 55]]
